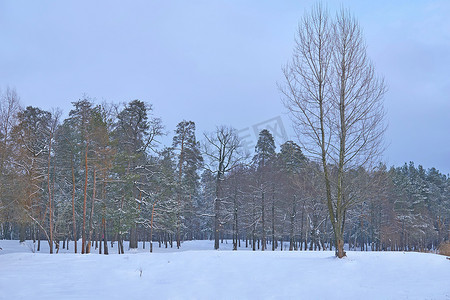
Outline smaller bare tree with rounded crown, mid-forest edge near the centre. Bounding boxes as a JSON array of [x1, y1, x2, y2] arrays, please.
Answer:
[[203, 126, 244, 249]]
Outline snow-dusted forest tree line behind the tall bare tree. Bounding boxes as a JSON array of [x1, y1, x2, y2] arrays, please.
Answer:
[[0, 89, 450, 254]]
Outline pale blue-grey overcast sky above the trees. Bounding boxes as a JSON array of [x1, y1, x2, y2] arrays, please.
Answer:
[[0, 0, 450, 174]]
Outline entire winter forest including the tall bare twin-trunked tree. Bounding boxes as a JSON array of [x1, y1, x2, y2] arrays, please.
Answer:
[[0, 4, 450, 258]]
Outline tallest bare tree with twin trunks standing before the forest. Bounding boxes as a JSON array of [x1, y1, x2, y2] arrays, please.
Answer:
[[280, 4, 386, 257]]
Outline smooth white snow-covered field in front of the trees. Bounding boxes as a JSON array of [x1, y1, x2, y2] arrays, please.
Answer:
[[0, 240, 450, 300]]
